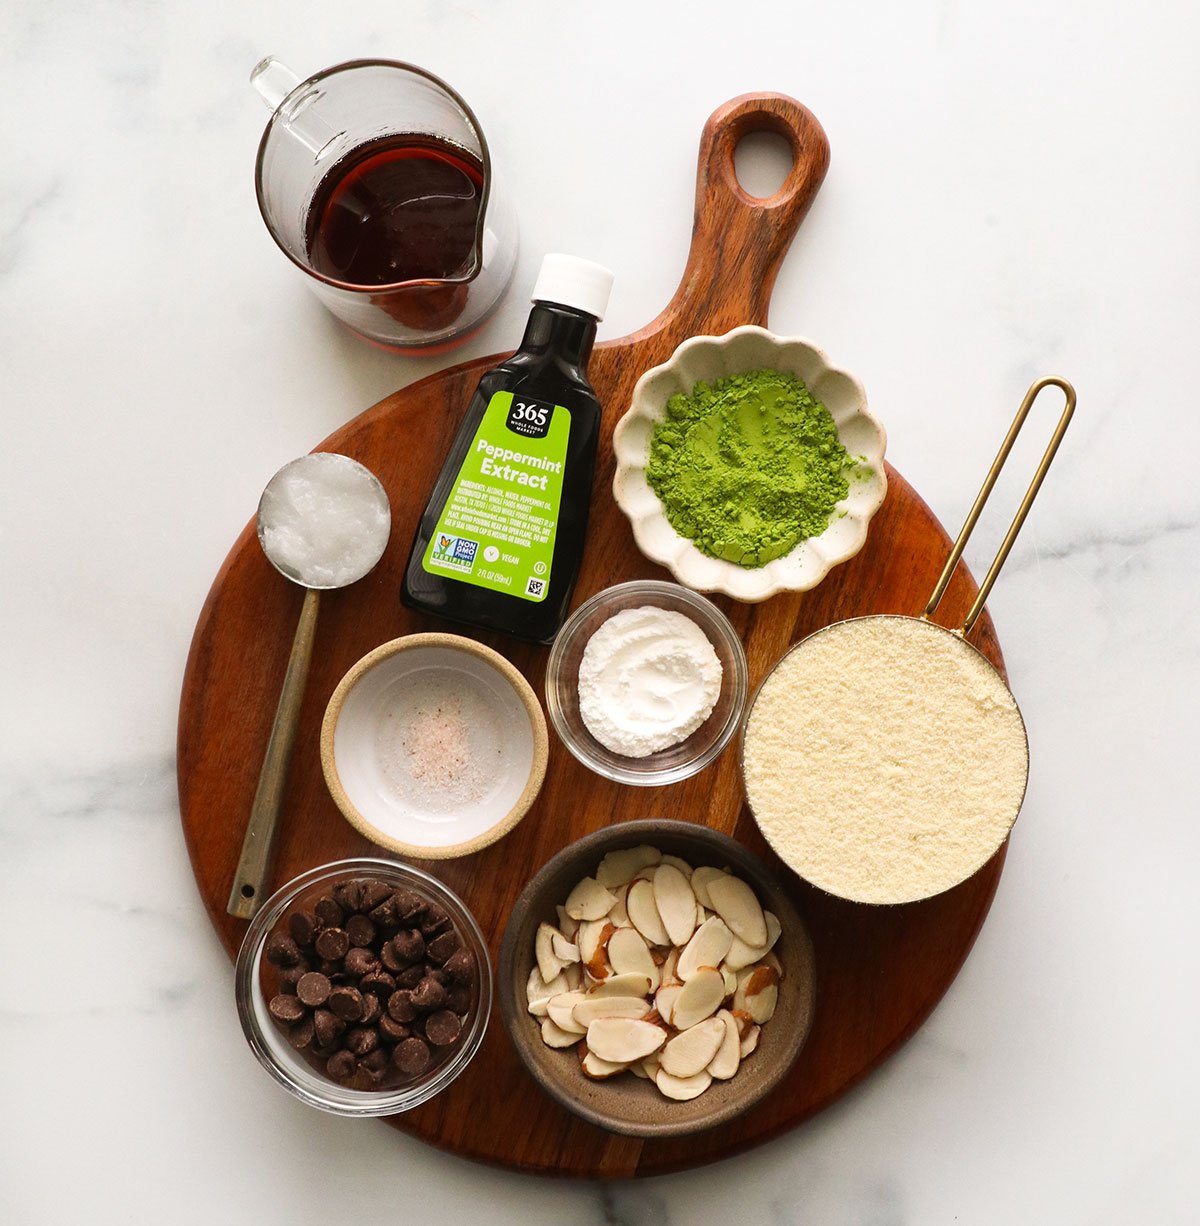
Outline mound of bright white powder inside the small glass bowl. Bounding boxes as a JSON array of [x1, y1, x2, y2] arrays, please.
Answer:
[[579, 606, 722, 758]]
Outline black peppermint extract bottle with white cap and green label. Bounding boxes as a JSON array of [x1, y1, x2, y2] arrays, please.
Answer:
[[401, 255, 613, 642]]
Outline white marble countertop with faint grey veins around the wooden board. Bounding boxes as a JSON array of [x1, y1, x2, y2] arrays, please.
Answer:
[[0, 0, 1200, 1226]]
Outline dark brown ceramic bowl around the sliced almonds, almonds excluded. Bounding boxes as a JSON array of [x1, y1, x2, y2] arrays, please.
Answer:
[[496, 820, 816, 1137]]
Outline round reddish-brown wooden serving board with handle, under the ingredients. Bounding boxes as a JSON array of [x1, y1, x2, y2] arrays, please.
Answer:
[[179, 94, 1004, 1177]]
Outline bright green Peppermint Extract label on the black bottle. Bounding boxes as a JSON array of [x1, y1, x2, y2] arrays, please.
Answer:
[[422, 391, 571, 601]]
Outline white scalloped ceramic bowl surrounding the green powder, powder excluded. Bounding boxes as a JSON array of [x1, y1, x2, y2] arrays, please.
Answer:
[[613, 325, 887, 602]]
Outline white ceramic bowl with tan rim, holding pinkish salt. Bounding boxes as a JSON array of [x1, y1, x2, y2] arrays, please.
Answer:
[[321, 634, 548, 859]]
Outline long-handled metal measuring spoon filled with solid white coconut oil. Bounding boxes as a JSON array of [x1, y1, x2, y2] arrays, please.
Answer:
[[226, 451, 391, 920]]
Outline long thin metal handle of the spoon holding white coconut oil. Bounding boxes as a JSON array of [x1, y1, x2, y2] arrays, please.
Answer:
[[226, 588, 321, 920]]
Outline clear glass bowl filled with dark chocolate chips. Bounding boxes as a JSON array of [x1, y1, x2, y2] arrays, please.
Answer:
[[235, 857, 492, 1116]]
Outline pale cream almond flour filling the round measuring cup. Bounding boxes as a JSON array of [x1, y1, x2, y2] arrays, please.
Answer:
[[743, 617, 1028, 904]]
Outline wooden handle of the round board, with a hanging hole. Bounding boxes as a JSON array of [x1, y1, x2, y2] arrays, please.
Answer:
[[646, 93, 829, 343]]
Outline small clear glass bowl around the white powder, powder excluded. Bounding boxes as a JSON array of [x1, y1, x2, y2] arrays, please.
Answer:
[[545, 579, 748, 787]]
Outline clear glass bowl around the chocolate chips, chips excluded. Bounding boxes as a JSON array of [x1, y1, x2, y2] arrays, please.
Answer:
[[234, 856, 492, 1116]]
